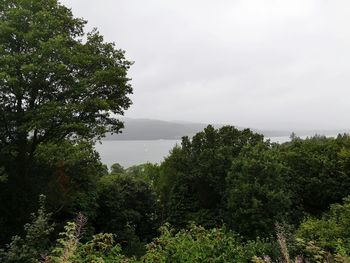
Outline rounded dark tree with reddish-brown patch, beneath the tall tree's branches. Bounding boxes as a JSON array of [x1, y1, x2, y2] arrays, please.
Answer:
[[35, 140, 108, 221]]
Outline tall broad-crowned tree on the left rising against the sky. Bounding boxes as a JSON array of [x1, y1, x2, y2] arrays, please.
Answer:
[[0, 0, 132, 243]]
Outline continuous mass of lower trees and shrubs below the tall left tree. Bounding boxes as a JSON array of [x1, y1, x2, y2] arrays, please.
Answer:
[[0, 126, 350, 262]]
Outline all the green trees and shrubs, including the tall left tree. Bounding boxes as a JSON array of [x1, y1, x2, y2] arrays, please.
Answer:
[[0, 0, 350, 263]]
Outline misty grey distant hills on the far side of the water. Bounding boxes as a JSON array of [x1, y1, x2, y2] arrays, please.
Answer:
[[103, 118, 346, 140]]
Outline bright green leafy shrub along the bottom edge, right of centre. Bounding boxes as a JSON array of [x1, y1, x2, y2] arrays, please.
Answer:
[[142, 225, 271, 263]]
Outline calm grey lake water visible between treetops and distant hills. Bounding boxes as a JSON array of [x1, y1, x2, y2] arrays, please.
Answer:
[[96, 136, 296, 168]]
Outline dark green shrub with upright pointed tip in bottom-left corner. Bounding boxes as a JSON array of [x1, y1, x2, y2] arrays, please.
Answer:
[[0, 195, 53, 263]]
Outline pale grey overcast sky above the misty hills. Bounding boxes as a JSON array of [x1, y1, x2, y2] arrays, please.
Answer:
[[61, 0, 350, 129]]
